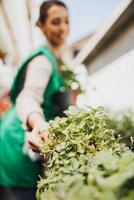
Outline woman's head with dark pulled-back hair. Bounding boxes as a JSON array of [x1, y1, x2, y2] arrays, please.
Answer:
[[37, 1, 69, 54]]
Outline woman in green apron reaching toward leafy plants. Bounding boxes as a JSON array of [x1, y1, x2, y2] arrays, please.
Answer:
[[0, 0, 69, 200]]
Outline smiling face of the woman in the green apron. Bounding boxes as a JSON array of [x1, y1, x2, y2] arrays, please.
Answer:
[[41, 5, 69, 47]]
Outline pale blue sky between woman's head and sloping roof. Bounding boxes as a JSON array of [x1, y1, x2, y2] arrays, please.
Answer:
[[62, 0, 123, 44]]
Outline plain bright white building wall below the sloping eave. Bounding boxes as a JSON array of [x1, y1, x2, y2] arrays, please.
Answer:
[[78, 49, 134, 110]]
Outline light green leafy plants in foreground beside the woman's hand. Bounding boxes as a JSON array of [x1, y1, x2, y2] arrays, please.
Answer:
[[37, 106, 134, 200]]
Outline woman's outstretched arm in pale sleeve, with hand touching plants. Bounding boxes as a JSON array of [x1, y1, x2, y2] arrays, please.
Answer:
[[16, 55, 51, 149]]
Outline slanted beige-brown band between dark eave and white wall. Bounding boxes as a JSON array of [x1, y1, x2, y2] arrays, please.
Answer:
[[86, 23, 134, 74]]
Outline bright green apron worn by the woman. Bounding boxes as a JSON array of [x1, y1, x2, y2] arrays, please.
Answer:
[[0, 46, 64, 187]]
